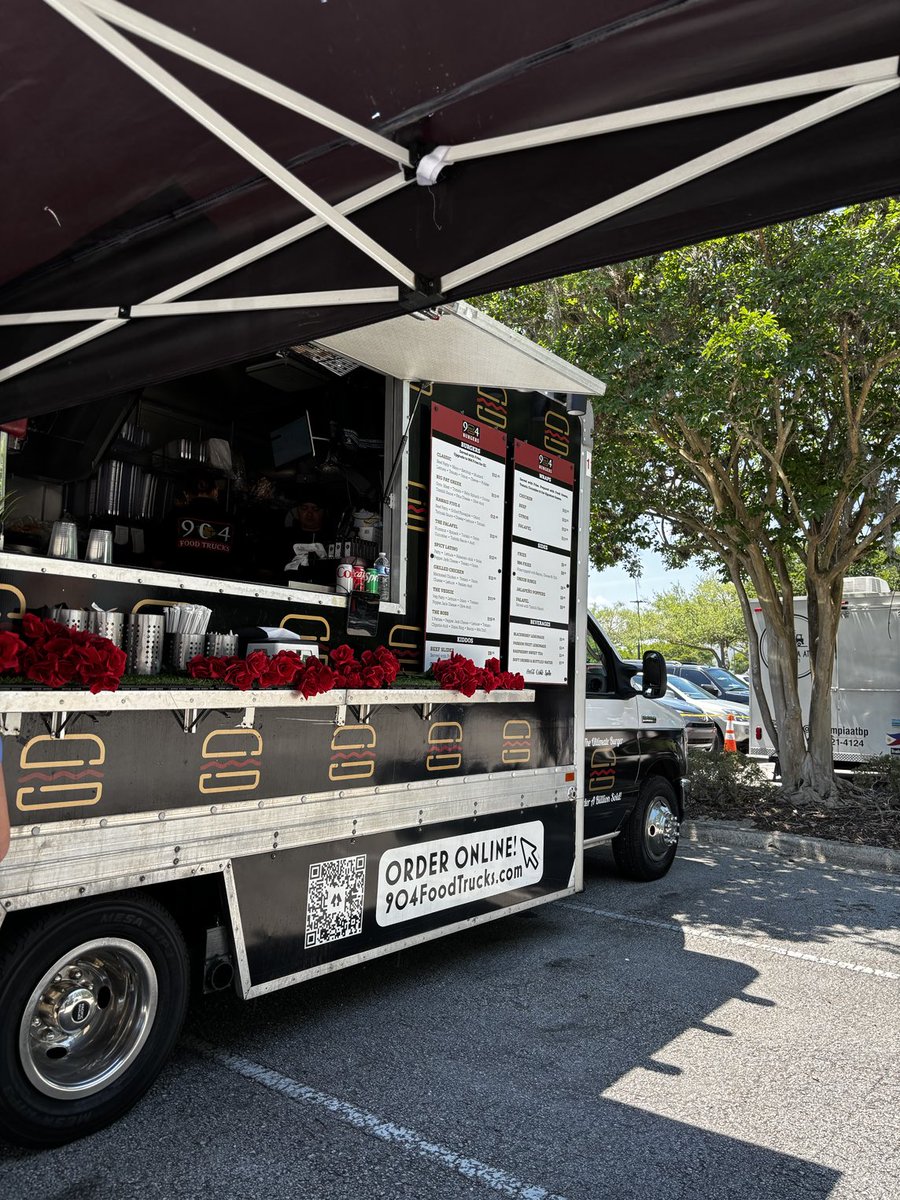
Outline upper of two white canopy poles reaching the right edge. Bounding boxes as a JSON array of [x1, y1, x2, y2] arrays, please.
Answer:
[[443, 55, 898, 164]]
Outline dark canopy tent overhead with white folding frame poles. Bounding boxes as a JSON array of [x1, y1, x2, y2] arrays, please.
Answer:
[[0, 0, 900, 420]]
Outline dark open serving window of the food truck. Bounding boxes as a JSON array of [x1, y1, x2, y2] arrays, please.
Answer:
[[4, 347, 408, 604]]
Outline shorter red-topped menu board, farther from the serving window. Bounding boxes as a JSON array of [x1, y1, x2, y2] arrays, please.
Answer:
[[508, 440, 575, 683]]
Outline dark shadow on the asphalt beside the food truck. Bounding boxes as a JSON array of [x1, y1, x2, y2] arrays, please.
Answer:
[[0, 849, 840, 1200]]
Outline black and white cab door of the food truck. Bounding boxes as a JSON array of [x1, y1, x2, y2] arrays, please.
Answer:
[[584, 623, 641, 841]]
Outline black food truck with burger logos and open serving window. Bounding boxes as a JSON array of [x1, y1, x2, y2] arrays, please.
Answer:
[[0, 304, 686, 1145]]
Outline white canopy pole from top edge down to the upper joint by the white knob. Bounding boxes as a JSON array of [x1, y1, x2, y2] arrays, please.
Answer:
[[82, 0, 410, 167]]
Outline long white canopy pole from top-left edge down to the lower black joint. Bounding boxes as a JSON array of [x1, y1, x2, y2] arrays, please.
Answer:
[[44, 0, 415, 288]]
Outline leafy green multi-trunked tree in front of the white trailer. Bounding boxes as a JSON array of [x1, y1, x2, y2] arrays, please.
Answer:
[[480, 199, 900, 803]]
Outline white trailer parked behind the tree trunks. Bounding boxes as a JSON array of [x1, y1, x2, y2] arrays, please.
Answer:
[[750, 576, 900, 767]]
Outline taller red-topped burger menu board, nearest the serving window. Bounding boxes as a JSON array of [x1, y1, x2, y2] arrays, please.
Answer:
[[425, 404, 506, 670]]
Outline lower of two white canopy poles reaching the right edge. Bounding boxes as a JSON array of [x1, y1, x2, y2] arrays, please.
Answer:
[[440, 78, 900, 293]]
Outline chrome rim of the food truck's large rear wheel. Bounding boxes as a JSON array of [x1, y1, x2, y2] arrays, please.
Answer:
[[19, 937, 158, 1099]]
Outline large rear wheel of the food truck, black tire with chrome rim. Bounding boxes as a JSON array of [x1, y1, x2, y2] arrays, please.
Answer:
[[0, 893, 188, 1147]]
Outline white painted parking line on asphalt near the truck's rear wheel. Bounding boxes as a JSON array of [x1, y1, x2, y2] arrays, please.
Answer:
[[182, 1038, 565, 1200]]
